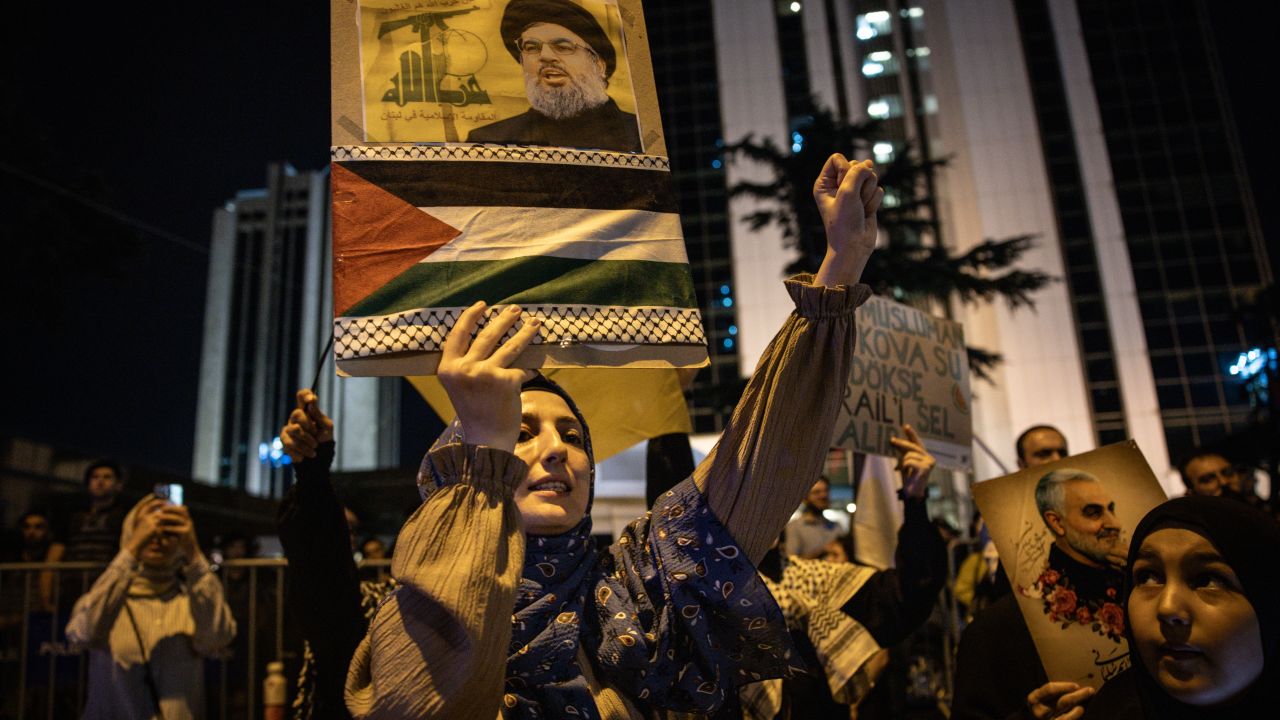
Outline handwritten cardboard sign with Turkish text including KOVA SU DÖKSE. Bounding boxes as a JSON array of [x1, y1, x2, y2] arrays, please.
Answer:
[[835, 297, 973, 470]]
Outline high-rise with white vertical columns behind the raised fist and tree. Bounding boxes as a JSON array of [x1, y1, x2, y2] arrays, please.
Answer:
[[645, 0, 1272, 489]]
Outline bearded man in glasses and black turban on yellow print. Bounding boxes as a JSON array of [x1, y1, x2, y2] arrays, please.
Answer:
[[467, 0, 643, 152]]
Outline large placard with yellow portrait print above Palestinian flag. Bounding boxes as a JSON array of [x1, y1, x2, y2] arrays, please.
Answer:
[[330, 0, 707, 375]]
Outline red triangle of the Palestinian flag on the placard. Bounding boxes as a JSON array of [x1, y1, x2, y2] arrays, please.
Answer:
[[330, 163, 462, 315]]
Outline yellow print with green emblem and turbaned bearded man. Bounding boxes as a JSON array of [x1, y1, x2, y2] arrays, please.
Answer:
[[358, 0, 650, 152]]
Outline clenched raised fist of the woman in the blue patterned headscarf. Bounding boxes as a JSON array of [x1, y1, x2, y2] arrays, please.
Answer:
[[813, 154, 884, 287]]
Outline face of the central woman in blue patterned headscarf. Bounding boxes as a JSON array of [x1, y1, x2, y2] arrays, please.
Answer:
[[516, 391, 591, 536]]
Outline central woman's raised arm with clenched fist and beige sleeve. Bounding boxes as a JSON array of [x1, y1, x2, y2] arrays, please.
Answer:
[[694, 155, 884, 562]]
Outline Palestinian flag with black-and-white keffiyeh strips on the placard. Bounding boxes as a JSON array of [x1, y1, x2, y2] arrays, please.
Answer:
[[332, 145, 707, 375]]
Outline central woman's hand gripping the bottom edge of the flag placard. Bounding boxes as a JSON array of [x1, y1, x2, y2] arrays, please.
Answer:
[[436, 301, 541, 452]]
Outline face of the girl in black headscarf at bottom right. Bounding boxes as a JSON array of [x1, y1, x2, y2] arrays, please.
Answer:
[[1129, 528, 1262, 706]]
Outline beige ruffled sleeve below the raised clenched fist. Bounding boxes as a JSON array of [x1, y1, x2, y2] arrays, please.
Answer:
[[694, 275, 872, 562]]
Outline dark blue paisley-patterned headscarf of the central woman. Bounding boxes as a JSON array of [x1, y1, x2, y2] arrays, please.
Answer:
[[419, 375, 791, 719]]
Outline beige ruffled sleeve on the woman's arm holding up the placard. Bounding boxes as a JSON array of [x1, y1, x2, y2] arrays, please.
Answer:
[[346, 443, 527, 720]]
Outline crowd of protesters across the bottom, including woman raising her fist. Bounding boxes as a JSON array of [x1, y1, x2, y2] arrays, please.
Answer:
[[0, 155, 1280, 720]]
